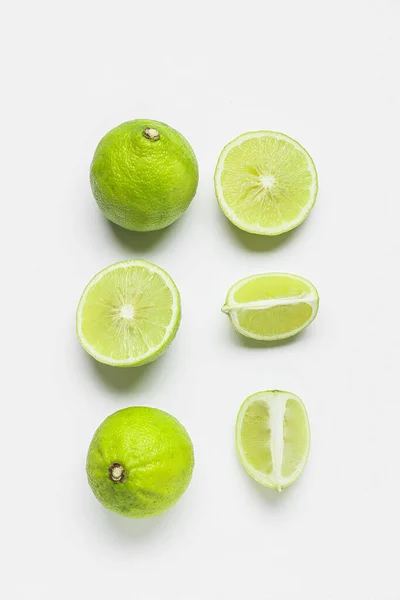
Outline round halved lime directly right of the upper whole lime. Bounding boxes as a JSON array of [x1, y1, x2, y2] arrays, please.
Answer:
[[214, 131, 318, 235]]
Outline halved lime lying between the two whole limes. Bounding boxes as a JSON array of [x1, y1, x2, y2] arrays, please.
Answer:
[[76, 260, 181, 367]]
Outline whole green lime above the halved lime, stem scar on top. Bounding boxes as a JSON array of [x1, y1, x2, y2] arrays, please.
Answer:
[[90, 119, 199, 231]]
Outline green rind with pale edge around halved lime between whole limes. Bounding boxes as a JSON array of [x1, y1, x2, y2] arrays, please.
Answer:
[[76, 259, 181, 367]]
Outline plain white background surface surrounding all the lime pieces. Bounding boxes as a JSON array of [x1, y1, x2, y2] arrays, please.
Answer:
[[0, 0, 400, 600]]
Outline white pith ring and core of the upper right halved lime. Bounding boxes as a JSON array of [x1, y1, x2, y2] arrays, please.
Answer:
[[215, 131, 318, 235]]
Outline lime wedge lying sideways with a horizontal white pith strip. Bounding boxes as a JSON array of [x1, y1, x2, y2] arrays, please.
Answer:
[[222, 273, 319, 341]]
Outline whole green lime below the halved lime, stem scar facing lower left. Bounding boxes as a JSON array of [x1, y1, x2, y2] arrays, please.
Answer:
[[86, 406, 194, 518]]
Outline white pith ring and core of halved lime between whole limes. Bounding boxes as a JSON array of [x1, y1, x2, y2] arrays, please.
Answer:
[[76, 260, 180, 366]]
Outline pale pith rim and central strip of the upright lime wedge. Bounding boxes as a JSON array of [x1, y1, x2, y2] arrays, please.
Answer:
[[236, 390, 310, 492]]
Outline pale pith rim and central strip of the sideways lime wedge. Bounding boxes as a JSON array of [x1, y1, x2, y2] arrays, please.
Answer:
[[222, 273, 319, 341]]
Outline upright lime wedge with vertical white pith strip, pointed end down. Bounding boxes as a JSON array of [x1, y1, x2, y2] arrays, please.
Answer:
[[236, 390, 310, 492]]
